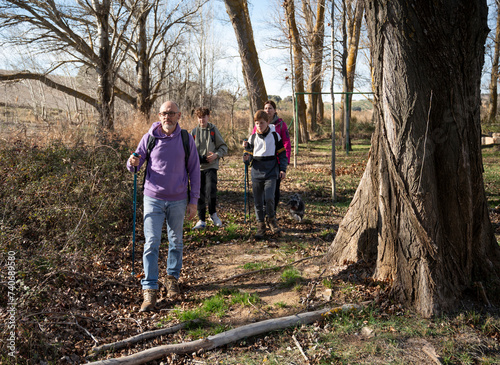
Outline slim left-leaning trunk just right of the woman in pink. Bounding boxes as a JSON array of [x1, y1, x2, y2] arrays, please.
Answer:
[[283, 0, 309, 143]]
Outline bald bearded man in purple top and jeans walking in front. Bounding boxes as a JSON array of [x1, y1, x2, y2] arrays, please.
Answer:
[[127, 101, 200, 312]]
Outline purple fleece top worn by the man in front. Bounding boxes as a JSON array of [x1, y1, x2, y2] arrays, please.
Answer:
[[127, 122, 200, 204]]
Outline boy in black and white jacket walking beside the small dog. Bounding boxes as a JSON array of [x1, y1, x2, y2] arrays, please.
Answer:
[[243, 110, 288, 239]]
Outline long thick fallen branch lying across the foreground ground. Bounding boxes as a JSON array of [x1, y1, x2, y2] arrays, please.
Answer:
[[88, 302, 368, 365]]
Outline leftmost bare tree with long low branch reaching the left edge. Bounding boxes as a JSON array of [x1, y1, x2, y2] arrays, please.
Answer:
[[0, 0, 139, 130]]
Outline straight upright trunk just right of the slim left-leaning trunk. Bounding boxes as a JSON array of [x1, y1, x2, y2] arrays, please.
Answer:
[[307, 0, 325, 132]]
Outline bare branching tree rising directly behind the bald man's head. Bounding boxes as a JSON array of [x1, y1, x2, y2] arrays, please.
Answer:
[[119, 0, 207, 120]]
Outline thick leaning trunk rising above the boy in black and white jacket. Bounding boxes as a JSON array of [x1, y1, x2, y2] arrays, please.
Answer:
[[224, 0, 267, 123]]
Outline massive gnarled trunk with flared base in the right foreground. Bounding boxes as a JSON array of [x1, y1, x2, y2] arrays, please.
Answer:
[[327, 0, 500, 316]]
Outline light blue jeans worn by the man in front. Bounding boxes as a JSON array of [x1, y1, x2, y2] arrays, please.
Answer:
[[141, 196, 187, 289]]
